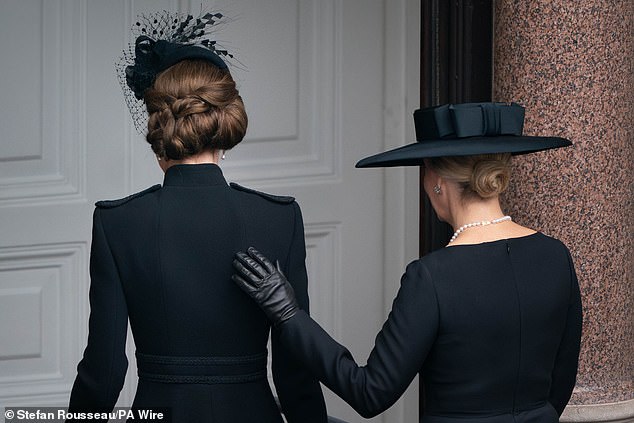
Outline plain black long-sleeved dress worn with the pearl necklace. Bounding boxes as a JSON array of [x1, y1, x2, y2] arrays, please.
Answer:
[[276, 233, 581, 423]]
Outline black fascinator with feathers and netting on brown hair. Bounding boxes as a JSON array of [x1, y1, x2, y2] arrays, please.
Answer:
[[116, 10, 234, 134]]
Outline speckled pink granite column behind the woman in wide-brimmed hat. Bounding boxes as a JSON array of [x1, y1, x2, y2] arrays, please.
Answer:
[[493, 0, 634, 422]]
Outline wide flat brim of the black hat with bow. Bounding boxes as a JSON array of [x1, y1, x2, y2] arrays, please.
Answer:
[[355, 135, 572, 168]]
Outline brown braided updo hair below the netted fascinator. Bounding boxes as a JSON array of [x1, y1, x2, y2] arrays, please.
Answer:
[[144, 60, 248, 160]]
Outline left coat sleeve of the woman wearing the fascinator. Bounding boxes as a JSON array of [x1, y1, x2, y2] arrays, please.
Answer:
[[68, 208, 128, 411]]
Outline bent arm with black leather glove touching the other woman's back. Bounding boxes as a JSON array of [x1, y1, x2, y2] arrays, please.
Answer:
[[234, 250, 438, 417]]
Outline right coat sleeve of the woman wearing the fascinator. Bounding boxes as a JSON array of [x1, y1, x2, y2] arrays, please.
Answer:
[[271, 203, 327, 423]]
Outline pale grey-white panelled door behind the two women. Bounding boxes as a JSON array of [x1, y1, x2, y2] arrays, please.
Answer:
[[0, 0, 418, 422]]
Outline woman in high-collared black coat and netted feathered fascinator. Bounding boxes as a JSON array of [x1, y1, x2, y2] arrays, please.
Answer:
[[69, 12, 327, 423]]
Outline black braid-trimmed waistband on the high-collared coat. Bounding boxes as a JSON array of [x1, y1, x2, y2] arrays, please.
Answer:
[[135, 351, 267, 384]]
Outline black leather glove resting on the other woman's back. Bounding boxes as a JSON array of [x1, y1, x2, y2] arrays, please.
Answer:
[[231, 247, 299, 326]]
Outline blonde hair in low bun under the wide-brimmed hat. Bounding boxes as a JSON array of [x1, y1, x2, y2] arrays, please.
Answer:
[[429, 153, 511, 198]]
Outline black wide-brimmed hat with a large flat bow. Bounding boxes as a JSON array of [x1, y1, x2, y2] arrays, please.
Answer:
[[356, 103, 572, 168]]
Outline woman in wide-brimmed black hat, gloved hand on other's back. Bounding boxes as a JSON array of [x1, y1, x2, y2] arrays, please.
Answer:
[[233, 103, 581, 423]]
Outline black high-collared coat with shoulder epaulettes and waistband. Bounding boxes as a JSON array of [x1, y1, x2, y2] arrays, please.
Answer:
[[69, 164, 326, 423]]
